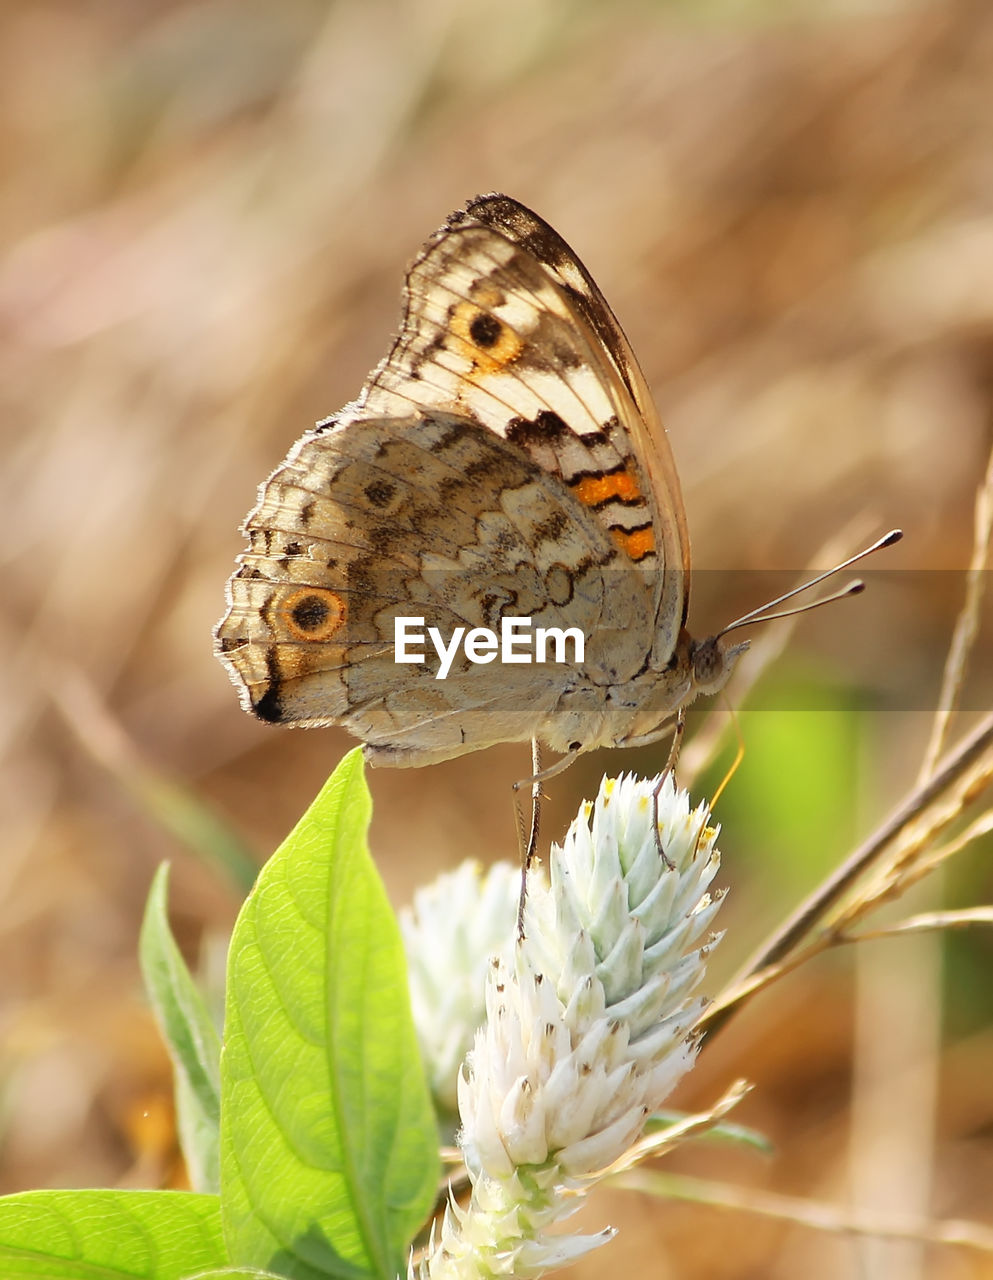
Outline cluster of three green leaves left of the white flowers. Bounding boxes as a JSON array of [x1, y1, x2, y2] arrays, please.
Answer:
[[0, 751, 439, 1280]]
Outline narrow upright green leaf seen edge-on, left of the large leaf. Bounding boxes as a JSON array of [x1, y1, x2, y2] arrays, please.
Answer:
[[138, 863, 220, 1192]]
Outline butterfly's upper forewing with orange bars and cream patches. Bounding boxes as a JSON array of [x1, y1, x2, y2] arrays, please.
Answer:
[[356, 195, 690, 669]]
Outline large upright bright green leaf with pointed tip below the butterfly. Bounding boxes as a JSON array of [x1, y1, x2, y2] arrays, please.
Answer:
[[221, 751, 439, 1280]]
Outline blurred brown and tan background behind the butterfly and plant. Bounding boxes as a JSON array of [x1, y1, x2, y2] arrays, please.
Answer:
[[0, 0, 993, 1277]]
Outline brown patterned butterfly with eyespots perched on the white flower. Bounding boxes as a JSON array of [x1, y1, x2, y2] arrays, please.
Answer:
[[215, 195, 745, 765]]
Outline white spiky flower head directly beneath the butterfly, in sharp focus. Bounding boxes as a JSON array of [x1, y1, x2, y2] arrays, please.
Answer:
[[418, 777, 719, 1280]]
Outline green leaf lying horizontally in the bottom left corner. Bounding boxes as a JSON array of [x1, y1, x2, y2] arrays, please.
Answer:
[[0, 1190, 228, 1280]]
